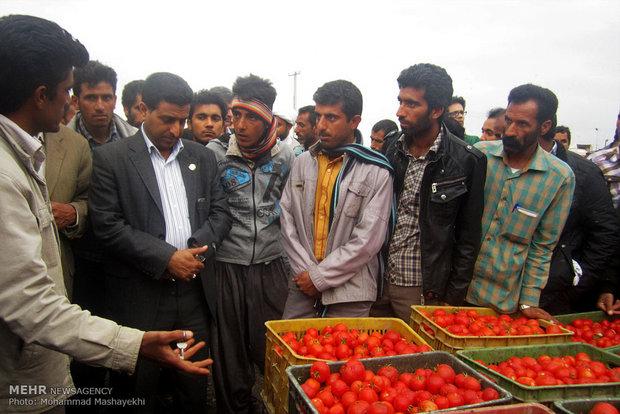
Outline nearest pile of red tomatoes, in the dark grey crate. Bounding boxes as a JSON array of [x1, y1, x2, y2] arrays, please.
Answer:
[[301, 359, 499, 414]]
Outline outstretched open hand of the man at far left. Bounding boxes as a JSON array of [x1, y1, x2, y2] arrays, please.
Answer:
[[140, 330, 213, 375]]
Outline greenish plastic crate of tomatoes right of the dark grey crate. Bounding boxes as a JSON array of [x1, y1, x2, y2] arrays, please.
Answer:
[[457, 343, 620, 402]]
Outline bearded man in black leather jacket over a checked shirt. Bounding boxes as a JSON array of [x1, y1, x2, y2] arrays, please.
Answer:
[[371, 63, 486, 321]]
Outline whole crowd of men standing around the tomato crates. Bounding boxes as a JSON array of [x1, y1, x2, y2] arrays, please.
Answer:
[[0, 16, 620, 413]]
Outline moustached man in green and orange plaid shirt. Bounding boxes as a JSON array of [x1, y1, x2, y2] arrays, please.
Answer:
[[466, 84, 575, 319]]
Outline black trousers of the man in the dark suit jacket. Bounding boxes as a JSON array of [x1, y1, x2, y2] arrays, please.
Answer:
[[110, 278, 210, 413]]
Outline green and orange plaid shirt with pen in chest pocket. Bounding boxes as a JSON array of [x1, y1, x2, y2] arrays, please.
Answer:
[[466, 141, 575, 313]]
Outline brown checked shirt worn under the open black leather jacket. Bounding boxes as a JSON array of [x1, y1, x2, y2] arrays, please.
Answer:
[[385, 129, 443, 286]]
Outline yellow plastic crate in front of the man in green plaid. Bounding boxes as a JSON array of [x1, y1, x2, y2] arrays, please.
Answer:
[[410, 305, 573, 354]]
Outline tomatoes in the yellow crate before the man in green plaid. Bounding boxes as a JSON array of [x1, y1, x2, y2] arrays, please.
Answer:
[[421, 308, 564, 336]]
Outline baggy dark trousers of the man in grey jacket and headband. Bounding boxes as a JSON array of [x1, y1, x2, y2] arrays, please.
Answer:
[[211, 258, 290, 414]]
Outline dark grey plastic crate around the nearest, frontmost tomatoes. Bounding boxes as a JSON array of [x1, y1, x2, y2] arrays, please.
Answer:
[[286, 352, 512, 414]]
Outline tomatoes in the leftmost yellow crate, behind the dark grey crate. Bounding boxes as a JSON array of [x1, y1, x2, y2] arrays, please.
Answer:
[[275, 323, 432, 361]]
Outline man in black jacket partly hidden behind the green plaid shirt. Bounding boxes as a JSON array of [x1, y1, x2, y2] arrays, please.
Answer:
[[538, 121, 620, 315]]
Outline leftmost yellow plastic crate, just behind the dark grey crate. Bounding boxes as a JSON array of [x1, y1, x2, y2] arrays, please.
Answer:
[[262, 318, 428, 414]]
